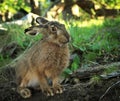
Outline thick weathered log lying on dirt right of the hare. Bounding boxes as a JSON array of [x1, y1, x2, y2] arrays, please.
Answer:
[[70, 62, 120, 80]]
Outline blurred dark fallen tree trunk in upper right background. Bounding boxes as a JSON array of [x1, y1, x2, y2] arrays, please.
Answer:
[[45, 0, 120, 19]]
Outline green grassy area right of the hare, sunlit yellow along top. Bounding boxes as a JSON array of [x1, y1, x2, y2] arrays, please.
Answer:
[[66, 17, 120, 73]]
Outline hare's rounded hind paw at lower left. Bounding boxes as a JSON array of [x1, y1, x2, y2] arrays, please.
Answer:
[[18, 88, 32, 99]]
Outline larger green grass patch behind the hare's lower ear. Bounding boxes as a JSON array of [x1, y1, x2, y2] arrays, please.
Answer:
[[4, 24, 41, 49]]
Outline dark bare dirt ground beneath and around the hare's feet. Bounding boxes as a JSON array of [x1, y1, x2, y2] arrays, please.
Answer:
[[0, 68, 120, 101]]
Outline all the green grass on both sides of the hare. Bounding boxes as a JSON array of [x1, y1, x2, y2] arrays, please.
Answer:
[[0, 17, 120, 73]]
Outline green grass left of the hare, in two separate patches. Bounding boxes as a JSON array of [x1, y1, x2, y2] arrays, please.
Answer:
[[0, 24, 42, 67]]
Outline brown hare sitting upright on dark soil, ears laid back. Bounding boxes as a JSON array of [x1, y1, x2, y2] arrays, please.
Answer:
[[16, 17, 70, 98]]
